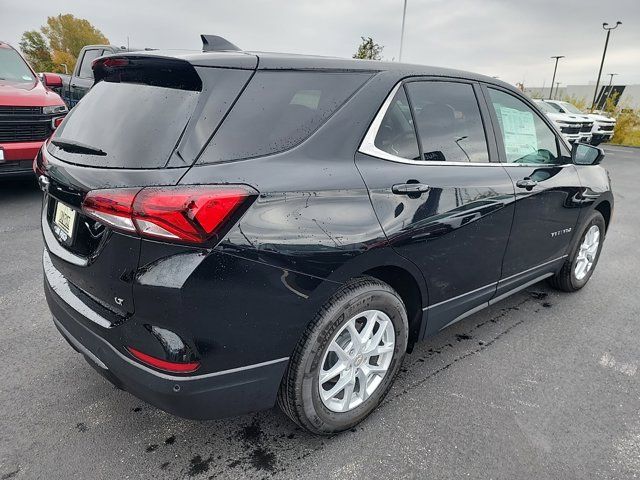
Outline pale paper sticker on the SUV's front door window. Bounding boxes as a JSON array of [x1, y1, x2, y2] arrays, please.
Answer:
[[495, 105, 538, 162]]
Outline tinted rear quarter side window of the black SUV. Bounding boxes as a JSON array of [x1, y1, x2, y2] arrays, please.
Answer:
[[201, 71, 371, 163]]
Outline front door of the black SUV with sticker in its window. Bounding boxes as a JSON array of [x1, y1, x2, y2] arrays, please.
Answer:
[[484, 86, 581, 297]]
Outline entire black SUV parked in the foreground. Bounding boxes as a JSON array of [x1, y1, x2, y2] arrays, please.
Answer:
[[34, 36, 613, 434]]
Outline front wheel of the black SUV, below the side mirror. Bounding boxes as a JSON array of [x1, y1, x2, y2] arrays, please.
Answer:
[[550, 211, 605, 292]]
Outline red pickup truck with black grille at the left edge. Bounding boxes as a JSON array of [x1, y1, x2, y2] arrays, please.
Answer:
[[0, 41, 68, 177]]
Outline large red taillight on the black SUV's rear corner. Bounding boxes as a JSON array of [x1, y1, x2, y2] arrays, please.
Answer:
[[82, 185, 257, 243]]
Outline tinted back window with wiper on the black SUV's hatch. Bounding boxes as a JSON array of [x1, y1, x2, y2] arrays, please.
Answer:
[[48, 81, 200, 168]]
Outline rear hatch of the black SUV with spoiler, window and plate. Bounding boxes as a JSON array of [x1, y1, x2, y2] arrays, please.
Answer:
[[36, 55, 255, 323]]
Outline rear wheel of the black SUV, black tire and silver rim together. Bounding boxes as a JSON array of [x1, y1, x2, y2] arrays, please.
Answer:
[[278, 277, 409, 435]]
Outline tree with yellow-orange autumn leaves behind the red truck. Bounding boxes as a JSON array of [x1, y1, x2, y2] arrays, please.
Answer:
[[20, 13, 109, 72]]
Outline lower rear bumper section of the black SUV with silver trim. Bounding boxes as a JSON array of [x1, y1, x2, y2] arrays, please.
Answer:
[[44, 260, 288, 420]]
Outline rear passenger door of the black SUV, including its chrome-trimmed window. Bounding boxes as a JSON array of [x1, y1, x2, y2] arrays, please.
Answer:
[[356, 79, 514, 334]]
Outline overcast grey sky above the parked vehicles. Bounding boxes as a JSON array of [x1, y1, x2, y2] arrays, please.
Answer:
[[0, 0, 640, 86]]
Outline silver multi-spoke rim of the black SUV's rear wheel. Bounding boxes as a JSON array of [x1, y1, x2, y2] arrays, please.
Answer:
[[318, 310, 395, 412]]
